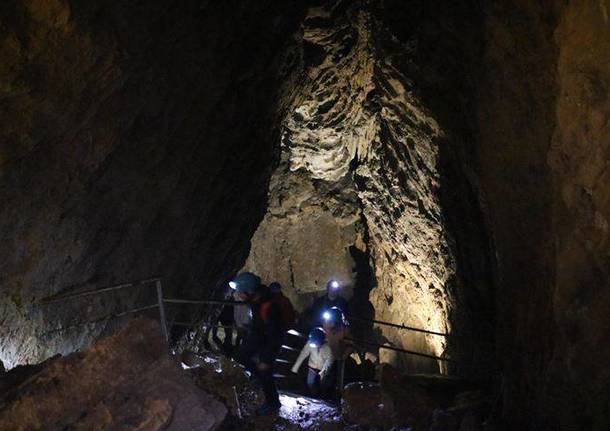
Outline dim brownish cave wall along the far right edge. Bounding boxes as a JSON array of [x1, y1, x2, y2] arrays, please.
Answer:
[[478, 1, 610, 430]]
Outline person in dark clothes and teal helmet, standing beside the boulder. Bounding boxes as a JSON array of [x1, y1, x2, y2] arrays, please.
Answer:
[[229, 272, 284, 416]]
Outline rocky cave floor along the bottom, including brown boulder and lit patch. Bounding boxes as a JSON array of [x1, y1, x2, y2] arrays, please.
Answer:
[[0, 319, 485, 431]]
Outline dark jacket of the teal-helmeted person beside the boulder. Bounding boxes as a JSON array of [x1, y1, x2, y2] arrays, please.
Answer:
[[250, 293, 284, 364]]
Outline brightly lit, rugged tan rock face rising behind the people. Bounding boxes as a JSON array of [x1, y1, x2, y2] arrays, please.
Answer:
[[246, 2, 480, 371]]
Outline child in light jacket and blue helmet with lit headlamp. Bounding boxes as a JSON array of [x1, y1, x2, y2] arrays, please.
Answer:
[[292, 328, 334, 396]]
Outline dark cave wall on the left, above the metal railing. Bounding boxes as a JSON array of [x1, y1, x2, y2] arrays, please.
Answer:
[[0, 0, 300, 367]]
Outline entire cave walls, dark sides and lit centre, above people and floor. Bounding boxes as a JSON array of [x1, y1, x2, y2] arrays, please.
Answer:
[[0, 0, 610, 430]]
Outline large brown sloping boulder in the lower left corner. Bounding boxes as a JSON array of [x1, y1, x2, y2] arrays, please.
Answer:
[[0, 319, 227, 431]]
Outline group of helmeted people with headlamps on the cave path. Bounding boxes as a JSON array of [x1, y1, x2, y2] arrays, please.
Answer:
[[225, 272, 350, 415]]
